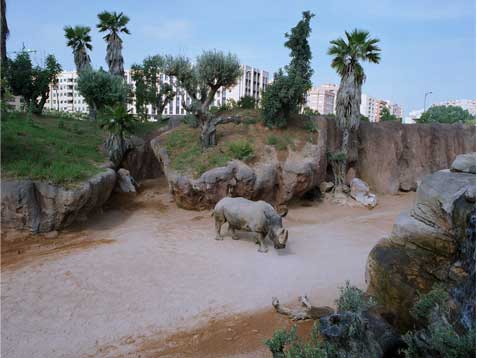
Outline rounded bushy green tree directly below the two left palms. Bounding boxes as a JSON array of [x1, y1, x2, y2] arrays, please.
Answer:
[[78, 68, 131, 119]]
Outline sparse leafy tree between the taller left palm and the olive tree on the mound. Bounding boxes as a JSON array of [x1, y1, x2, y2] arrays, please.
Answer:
[[132, 55, 176, 119]]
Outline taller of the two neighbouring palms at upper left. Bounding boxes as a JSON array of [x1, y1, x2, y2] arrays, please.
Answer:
[[96, 11, 130, 76]]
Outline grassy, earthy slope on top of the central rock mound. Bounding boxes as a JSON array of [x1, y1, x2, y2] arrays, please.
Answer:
[[161, 110, 318, 177]]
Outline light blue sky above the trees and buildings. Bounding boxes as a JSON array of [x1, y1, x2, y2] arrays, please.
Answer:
[[7, 0, 476, 114]]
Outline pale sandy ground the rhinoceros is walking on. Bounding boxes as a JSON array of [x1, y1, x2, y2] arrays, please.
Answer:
[[1, 180, 414, 358]]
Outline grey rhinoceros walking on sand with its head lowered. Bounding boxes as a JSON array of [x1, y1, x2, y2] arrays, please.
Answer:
[[213, 197, 288, 252]]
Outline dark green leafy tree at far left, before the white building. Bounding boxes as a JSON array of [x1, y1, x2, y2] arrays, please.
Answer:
[[7, 52, 62, 114]]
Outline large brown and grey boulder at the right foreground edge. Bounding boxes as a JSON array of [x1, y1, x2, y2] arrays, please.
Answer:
[[366, 170, 475, 330]]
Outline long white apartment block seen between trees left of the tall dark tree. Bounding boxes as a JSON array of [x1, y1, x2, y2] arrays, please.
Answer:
[[45, 65, 269, 116]]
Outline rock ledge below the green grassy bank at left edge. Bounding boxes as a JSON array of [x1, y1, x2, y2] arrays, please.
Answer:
[[1, 169, 116, 233]]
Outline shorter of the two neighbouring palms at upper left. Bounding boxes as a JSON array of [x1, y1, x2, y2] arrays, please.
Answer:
[[64, 26, 93, 73]]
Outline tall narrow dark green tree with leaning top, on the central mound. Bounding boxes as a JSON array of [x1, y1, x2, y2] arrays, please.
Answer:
[[262, 11, 314, 127]]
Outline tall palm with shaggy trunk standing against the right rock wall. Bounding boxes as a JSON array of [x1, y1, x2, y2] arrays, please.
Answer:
[[328, 29, 381, 186]]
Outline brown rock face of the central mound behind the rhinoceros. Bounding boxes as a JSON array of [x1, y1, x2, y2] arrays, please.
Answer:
[[151, 127, 326, 210]]
